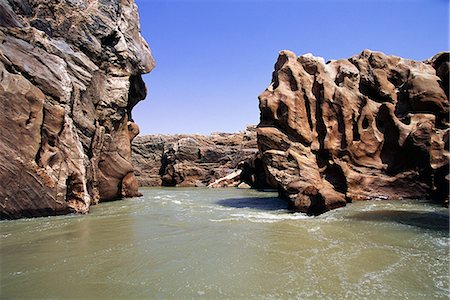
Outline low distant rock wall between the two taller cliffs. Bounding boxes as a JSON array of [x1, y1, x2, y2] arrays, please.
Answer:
[[132, 126, 266, 188]]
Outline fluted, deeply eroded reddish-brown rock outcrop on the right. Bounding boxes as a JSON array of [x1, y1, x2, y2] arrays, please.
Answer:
[[258, 50, 449, 214]]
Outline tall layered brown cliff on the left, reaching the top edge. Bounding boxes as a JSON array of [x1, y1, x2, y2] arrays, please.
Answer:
[[0, 0, 154, 218]]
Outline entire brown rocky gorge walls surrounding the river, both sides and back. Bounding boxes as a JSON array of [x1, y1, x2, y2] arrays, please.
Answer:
[[0, 0, 449, 219]]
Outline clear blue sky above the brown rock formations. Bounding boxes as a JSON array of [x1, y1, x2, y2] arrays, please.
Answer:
[[133, 0, 449, 134]]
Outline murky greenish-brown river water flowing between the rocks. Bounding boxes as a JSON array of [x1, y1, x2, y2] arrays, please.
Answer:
[[0, 188, 449, 299]]
